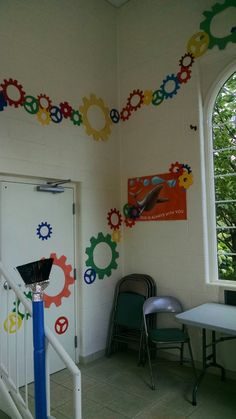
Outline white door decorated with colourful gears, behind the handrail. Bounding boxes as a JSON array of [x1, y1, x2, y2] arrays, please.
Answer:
[[0, 182, 76, 382]]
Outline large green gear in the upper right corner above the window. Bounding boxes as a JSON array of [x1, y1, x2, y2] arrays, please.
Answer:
[[200, 0, 236, 49]]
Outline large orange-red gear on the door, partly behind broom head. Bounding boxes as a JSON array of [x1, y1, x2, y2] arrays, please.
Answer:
[[44, 253, 75, 308]]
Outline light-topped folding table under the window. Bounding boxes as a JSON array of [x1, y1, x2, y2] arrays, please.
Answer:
[[176, 303, 236, 406]]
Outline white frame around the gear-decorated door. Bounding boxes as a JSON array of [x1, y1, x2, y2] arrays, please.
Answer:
[[0, 174, 81, 362]]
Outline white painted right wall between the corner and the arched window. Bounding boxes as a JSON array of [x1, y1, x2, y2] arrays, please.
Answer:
[[118, 0, 236, 370]]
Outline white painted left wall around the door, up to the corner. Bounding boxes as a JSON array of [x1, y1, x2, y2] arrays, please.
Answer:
[[0, 0, 121, 357]]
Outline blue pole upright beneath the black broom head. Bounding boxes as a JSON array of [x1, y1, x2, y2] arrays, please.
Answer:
[[32, 294, 47, 419]]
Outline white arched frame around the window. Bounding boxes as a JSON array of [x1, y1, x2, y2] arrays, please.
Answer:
[[202, 62, 236, 289]]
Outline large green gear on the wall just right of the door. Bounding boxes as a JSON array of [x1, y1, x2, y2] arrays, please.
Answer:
[[85, 232, 119, 279]]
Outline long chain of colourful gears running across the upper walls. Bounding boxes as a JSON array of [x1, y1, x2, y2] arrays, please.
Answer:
[[0, 0, 236, 140]]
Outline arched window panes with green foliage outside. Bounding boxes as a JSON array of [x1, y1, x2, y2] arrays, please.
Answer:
[[208, 71, 236, 284]]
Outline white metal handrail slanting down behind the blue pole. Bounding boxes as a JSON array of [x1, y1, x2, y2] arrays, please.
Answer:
[[0, 261, 82, 419]]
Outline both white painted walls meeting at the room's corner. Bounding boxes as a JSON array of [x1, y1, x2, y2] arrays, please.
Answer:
[[0, 0, 236, 369]]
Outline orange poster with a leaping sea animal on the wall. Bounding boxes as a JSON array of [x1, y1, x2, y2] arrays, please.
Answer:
[[128, 173, 187, 221]]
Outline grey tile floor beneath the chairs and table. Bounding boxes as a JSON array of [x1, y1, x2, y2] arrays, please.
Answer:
[[12, 352, 236, 419]]
